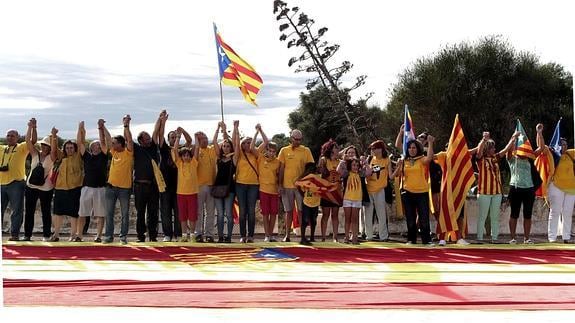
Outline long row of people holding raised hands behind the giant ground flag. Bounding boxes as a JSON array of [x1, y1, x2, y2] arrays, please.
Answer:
[[0, 110, 575, 245]]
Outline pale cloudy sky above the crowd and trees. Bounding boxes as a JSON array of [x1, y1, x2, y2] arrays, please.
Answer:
[[0, 0, 575, 137]]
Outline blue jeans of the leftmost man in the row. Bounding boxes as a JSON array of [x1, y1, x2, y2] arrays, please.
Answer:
[[0, 181, 26, 237]]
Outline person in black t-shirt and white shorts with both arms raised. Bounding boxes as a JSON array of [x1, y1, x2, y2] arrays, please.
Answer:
[[75, 119, 108, 242]]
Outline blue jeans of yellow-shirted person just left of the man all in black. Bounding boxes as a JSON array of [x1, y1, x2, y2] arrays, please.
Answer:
[[104, 186, 132, 240]]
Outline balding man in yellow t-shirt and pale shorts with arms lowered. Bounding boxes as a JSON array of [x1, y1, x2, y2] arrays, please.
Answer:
[[278, 129, 314, 242]]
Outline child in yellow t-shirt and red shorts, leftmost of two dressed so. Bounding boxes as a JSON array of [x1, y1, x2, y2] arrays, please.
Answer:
[[172, 127, 200, 242]]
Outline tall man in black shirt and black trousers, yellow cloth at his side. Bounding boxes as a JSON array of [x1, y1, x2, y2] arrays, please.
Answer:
[[134, 111, 165, 242]]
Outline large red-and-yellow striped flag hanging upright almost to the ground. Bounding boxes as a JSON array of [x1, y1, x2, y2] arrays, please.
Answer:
[[439, 115, 475, 232]]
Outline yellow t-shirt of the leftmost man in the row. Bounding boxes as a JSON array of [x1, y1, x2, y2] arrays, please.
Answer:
[[0, 142, 28, 185]]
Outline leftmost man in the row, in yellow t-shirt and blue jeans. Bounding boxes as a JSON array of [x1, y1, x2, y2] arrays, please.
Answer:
[[0, 118, 37, 241]]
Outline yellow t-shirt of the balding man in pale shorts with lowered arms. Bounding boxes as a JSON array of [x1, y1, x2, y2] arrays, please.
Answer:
[[278, 145, 314, 188]]
